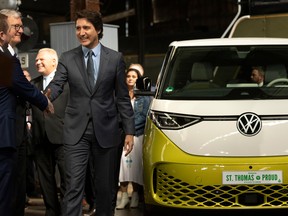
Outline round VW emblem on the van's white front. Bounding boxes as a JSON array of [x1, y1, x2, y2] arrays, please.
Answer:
[[237, 113, 262, 136]]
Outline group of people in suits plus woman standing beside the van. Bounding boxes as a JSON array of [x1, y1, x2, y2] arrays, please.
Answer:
[[0, 6, 151, 216]]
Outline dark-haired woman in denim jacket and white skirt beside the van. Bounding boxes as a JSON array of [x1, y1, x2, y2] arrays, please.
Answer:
[[116, 64, 151, 209]]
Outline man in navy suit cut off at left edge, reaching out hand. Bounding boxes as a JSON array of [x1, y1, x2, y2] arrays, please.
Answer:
[[0, 14, 53, 215]]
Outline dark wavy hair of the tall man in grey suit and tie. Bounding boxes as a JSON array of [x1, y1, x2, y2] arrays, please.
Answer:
[[75, 10, 103, 40]]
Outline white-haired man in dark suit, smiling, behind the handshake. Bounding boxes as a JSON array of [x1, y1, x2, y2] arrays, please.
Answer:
[[31, 48, 69, 216]]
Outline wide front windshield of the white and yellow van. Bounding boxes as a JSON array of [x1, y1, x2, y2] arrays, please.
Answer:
[[159, 45, 288, 100]]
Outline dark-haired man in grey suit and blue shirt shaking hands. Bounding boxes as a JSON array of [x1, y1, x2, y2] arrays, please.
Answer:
[[47, 10, 135, 216]]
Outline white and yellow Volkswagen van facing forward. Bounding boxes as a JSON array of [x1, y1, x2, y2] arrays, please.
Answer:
[[143, 38, 288, 213]]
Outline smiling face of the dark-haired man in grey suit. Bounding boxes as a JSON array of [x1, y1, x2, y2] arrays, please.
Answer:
[[76, 18, 100, 49]]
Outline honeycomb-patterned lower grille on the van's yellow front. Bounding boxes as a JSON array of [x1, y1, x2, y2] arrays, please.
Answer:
[[154, 169, 288, 208]]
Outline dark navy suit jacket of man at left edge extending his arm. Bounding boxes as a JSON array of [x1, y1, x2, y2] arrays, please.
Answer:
[[0, 51, 48, 149]]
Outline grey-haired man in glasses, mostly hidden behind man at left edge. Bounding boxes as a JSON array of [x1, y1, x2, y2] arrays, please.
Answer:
[[0, 9, 28, 216]]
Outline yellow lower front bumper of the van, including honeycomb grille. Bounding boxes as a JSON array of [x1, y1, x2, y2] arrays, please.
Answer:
[[143, 120, 288, 209]]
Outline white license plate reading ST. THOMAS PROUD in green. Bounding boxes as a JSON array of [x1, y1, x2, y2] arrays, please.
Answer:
[[222, 170, 283, 185]]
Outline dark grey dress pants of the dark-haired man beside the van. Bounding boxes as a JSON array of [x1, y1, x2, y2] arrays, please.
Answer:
[[62, 122, 116, 216]]
